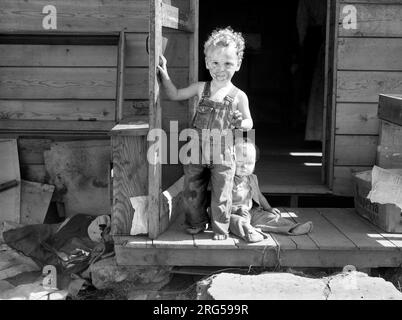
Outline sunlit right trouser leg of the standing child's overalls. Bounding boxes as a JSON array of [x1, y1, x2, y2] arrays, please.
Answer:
[[211, 164, 235, 235]]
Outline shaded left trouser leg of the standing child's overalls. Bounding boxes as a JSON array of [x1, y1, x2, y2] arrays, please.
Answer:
[[183, 164, 209, 228]]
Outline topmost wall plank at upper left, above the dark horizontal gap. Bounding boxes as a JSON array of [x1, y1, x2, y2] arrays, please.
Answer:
[[0, 0, 149, 33]]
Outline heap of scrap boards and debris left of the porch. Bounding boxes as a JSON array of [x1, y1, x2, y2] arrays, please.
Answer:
[[0, 139, 114, 299]]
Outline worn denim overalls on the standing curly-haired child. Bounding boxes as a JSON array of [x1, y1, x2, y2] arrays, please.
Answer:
[[183, 82, 239, 234]]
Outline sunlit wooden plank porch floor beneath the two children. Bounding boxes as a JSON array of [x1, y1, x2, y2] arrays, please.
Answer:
[[115, 208, 402, 268]]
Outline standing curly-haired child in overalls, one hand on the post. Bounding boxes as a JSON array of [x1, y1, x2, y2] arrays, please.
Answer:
[[158, 27, 253, 240]]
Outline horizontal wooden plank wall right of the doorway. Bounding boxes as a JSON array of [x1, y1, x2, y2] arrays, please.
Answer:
[[333, 0, 402, 196]]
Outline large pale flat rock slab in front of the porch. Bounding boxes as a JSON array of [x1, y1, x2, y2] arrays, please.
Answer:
[[197, 271, 402, 300]]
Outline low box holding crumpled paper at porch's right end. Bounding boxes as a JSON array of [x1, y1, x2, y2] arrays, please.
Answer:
[[353, 170, 402, 233]]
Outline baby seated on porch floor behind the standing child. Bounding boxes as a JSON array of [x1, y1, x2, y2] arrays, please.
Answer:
[[230, 140, 313, 242]]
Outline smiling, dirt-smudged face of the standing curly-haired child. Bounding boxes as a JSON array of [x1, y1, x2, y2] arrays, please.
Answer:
[[205, 45, 241, 83]]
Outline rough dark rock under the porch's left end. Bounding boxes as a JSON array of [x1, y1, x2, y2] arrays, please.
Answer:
[[89, 257, 171, 290]]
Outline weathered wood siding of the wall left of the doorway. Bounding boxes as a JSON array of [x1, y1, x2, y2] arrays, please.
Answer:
[[0, 0, 190, 218]]
